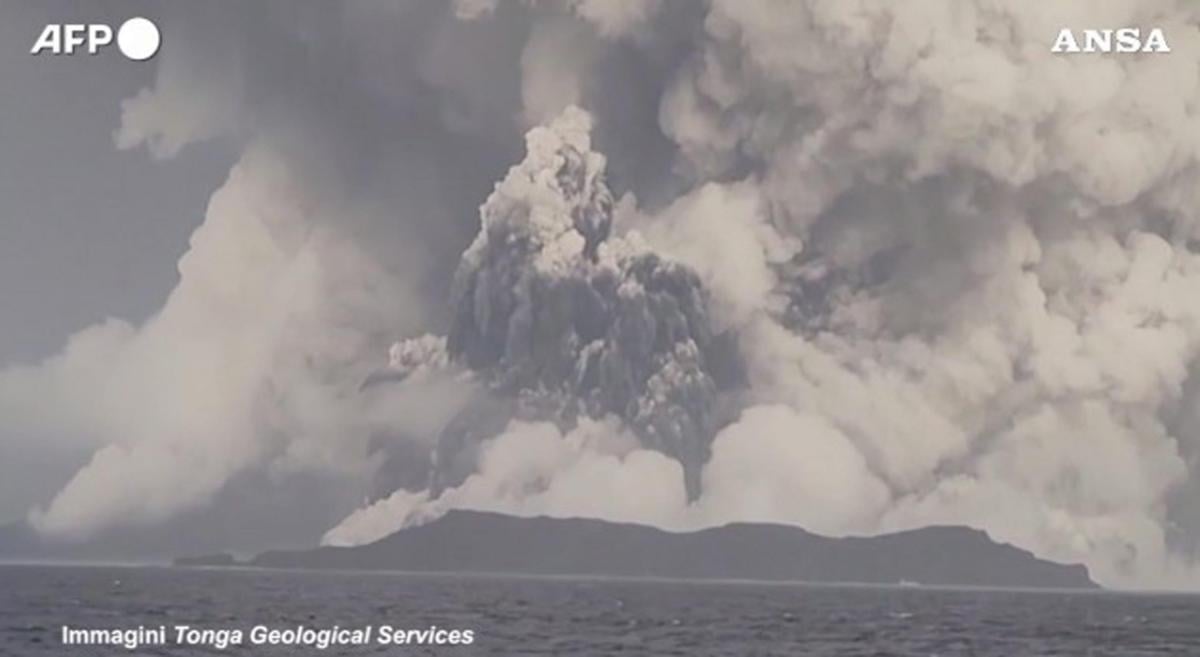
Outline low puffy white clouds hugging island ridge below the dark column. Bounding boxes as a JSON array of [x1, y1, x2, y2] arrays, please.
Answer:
[[322, 405, 887, 546]]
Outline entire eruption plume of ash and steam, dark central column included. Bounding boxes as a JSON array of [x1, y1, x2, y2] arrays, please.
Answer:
[[0, 0, 1200, 586]]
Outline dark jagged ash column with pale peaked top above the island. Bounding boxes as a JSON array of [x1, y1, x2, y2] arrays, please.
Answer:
[[381, 108, 732, 498]]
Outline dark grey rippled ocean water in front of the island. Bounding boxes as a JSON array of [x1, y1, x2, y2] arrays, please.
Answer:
[[0, 566, 1200, 657]]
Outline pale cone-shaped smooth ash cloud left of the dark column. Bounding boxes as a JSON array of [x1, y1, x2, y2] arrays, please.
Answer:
[[18, 150, 415, 535]]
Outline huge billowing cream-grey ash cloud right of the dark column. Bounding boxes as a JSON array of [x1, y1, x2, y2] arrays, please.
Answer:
[[331, 2, 1200, 586]]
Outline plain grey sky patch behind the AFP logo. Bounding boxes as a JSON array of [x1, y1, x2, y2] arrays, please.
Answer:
[[0, 2, 236, 364]]
